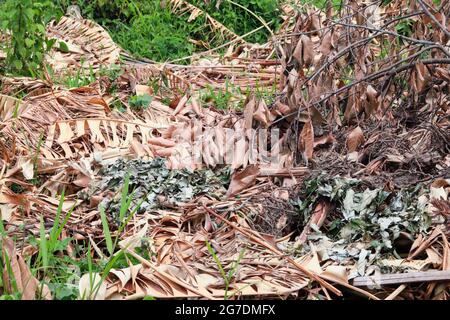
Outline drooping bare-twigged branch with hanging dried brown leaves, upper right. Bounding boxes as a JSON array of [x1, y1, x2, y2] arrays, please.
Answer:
[[274, 1, 450, 159]]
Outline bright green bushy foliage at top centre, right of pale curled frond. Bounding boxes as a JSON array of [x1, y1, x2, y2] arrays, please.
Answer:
[[51, 0, 280, 61]]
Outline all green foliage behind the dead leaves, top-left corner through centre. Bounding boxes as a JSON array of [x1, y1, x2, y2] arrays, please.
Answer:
[[0, 0, 281, 70]]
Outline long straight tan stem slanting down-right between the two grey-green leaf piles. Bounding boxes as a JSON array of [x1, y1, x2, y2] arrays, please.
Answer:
[[203, 206, 342, 296]]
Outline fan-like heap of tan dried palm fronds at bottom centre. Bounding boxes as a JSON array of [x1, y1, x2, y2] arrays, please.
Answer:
[[84, 209, 326, 299]]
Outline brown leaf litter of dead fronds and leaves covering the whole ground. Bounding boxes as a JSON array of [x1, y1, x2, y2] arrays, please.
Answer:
[[0, 1, 450, 299]]
